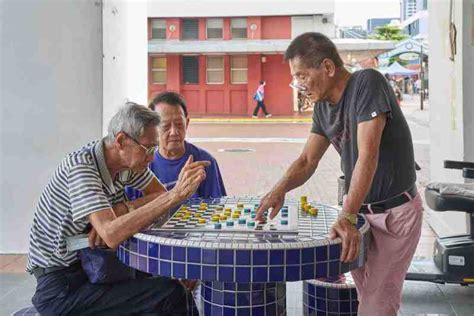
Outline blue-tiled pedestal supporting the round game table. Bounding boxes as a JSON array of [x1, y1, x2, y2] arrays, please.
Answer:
[[201, 282, 286, 316]]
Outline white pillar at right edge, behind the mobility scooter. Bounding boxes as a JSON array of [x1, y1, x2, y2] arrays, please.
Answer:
[[428, 0, 474, 236]]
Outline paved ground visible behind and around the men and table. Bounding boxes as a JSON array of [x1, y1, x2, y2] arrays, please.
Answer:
[[0, 98, 474, 316]]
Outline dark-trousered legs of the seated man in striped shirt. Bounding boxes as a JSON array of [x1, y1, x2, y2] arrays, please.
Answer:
[[32, 267, 193, 315]]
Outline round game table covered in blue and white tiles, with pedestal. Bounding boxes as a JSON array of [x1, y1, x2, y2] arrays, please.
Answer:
[[118, 197, 370, 316]]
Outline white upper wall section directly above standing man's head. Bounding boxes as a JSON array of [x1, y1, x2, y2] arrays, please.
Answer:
[[291, 14, 336, 38]]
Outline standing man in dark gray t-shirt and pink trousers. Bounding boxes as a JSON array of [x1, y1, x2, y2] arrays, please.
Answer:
[[257, 33, 423, 316]]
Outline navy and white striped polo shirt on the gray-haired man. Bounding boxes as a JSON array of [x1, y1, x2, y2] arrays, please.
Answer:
[[26, 140, 154, 273]]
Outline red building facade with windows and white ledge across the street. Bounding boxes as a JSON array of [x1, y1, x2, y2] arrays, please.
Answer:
[[148, 16, 294, 115]]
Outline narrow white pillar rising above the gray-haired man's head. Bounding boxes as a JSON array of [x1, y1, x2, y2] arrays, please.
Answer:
[[103, 0, 148, 134]]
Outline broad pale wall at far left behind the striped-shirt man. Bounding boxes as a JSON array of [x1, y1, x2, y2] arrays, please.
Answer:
[[0, 0, 102, 253]]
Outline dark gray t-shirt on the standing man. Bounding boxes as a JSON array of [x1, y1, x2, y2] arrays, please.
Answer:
[[311, 69, 416, 203]]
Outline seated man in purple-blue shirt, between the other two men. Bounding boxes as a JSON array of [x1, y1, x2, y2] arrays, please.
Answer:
[[125, 91, 226, 200]]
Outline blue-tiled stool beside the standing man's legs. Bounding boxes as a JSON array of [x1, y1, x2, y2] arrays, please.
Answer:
[[303, 274, 359, 316]]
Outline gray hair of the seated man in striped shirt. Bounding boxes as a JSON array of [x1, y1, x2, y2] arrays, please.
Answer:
[[105, 102, 160, 144]]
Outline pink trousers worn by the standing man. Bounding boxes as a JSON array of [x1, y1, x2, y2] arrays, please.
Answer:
[[352, 194, 423, 316]]
